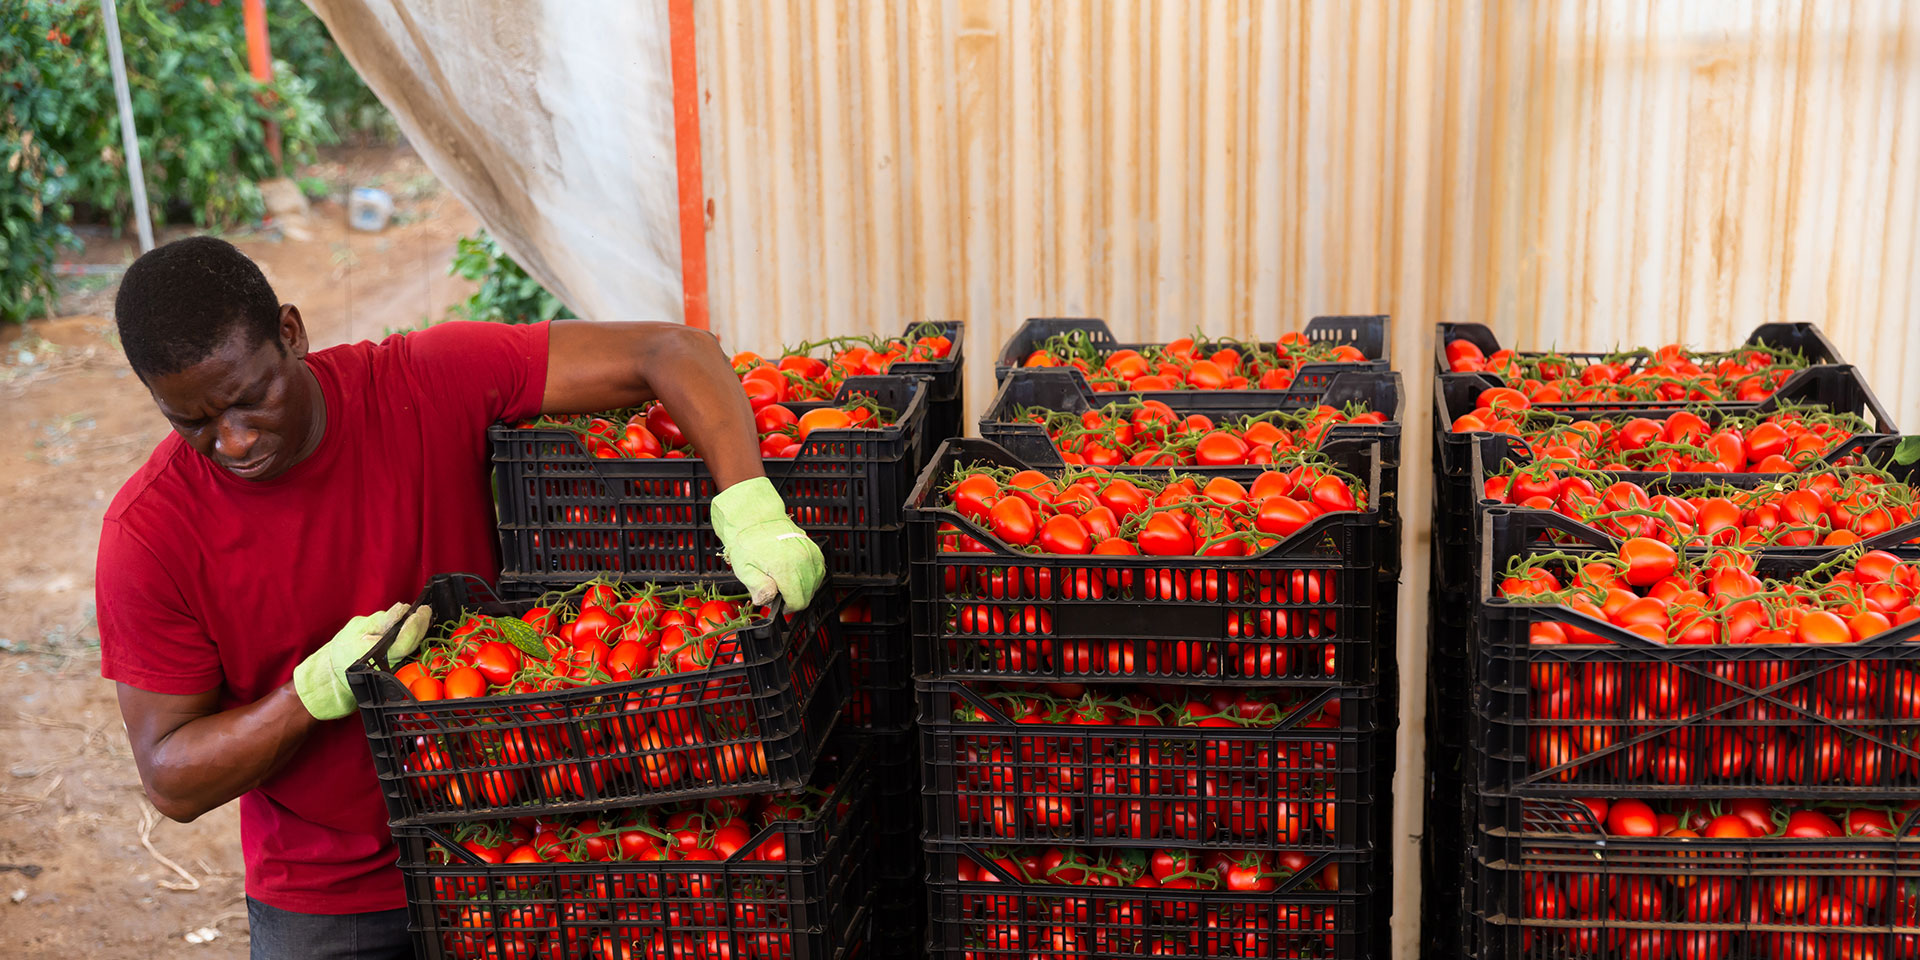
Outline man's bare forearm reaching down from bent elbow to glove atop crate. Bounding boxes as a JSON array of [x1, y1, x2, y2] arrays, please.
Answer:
[[645, 326, 766, 490]]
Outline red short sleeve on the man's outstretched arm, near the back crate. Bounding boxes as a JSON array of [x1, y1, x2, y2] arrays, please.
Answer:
[[401, 321, 549, 428]]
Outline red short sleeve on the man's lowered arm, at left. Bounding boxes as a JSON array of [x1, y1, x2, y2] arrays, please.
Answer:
[[94, 518, 225, 695]]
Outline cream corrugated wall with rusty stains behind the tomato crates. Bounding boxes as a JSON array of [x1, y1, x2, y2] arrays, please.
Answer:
[[697, 0, 1920, 956]]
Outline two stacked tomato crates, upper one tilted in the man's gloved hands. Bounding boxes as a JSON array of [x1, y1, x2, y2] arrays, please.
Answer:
[[348, 576, 874, 960]]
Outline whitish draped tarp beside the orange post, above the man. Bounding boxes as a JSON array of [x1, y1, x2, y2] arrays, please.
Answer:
[[307, 0, 682, 321]]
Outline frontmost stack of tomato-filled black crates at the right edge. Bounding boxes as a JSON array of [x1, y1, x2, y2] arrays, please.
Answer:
[[1473, 509, 1920, 960]]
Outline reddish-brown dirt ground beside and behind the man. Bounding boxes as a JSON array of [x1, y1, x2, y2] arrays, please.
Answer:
[[0, 148, 478, 960]]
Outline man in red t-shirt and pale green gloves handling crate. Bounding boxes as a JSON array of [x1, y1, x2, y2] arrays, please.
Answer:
[[96, 238, 826, 960]]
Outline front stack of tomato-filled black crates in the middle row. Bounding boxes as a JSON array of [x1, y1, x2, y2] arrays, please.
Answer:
[[908, 440, 1386, 958]]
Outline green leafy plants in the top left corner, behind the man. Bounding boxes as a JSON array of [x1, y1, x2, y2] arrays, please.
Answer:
[[0, 0, 397, 323]]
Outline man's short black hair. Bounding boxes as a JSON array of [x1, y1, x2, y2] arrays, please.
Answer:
[[113, 236, 284, 380]]
